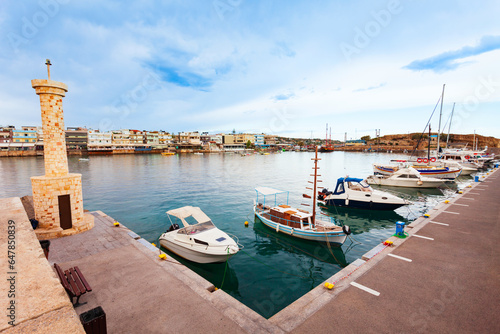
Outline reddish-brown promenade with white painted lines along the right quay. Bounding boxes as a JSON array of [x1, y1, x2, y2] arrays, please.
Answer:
[[293, 170, 500, 333]]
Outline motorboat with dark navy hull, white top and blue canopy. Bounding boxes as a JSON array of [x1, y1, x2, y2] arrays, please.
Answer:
[[318, 177, 410, 210]]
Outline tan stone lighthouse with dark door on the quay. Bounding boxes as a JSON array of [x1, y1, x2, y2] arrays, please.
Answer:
[[31, 59, 94, 239]]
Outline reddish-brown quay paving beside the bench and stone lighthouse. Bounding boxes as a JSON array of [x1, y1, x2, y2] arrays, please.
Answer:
[[49, 212, 281, 333]]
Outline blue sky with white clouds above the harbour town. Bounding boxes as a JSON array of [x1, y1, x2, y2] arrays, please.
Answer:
[[0, 0, 500, 139]]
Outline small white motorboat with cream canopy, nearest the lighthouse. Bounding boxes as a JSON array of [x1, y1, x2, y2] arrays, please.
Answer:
[[160, 206, 240, 263]]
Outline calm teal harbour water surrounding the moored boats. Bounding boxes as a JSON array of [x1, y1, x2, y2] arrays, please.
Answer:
[[0, 152, 472, 318]]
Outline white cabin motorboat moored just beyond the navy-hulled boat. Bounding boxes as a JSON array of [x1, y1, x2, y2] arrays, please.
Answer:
[[366, 167, 445, 188]]
